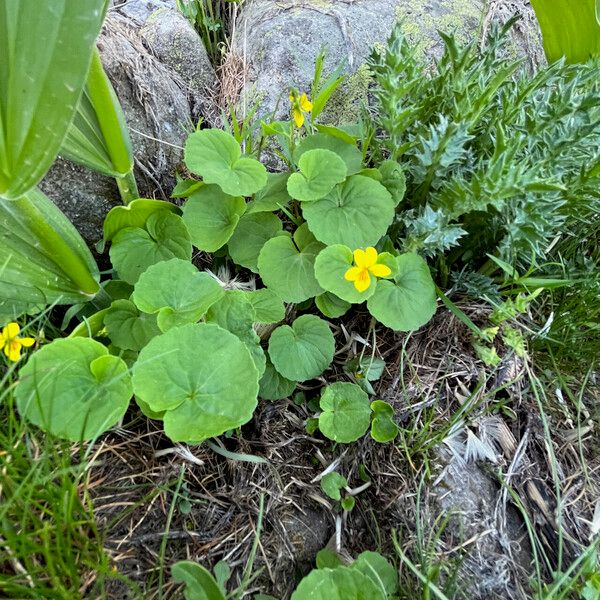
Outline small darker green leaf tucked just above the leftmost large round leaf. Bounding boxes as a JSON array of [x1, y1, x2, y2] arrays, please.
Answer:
[[104, 300, 161, 351]]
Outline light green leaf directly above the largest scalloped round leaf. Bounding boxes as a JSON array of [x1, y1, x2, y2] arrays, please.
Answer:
[[132, 258, 225, 331]]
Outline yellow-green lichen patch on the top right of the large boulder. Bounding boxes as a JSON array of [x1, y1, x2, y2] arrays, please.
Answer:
[[396, 0, 483, 57]]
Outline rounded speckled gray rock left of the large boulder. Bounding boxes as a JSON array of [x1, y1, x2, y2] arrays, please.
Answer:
[[140, 8, 217, 113]]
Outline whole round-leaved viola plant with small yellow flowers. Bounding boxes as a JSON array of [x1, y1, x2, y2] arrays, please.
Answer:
[[15, 75, 436, 443]]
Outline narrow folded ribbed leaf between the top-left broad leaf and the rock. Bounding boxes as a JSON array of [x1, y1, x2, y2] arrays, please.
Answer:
[[60, 50, 133, 177]]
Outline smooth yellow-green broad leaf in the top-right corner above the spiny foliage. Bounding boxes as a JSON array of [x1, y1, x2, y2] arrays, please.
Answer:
[[531, 0, 600, 63]]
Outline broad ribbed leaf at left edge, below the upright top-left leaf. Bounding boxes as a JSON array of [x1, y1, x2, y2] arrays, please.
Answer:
[[0, 188, 100, 322]]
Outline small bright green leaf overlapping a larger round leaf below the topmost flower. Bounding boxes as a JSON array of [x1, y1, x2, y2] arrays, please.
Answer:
[[287, 149, 347, 202]]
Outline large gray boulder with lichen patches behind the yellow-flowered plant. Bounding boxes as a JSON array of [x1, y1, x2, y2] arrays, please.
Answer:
[[233, 0, 541, 123]]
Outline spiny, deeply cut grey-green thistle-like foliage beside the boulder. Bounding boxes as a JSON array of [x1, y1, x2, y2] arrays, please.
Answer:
[[370, 23, 600, 270]]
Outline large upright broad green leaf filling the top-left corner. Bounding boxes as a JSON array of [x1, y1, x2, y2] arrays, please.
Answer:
[[0, 0, 106, 199]]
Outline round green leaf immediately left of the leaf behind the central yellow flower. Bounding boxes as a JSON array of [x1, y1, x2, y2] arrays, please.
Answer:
[[258, 235, 323, 303]]
